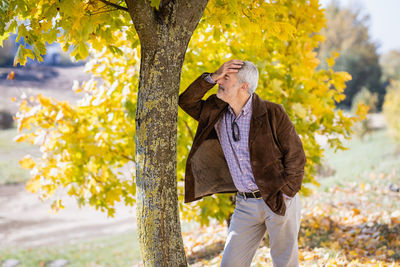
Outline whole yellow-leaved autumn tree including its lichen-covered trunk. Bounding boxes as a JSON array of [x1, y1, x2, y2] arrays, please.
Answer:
[[0, 0, 366, 266]]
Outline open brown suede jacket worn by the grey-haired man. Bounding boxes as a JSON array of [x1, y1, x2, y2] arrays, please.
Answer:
[[179, 72, 306, 216]]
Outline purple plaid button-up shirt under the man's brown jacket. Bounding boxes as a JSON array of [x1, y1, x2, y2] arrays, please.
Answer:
[[205, 74, 290, 198]]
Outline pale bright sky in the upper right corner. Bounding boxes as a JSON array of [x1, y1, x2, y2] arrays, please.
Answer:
[[320, 0, 400, 54]]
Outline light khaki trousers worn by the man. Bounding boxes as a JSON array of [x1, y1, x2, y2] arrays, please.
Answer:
[[221, 193, 301, 267]]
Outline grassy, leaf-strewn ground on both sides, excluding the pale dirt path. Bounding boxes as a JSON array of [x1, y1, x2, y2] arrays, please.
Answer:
[[0, 127, 400, 267]]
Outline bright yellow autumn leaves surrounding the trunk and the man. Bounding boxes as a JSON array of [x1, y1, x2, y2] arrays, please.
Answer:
[[0, 0, 367, 224]]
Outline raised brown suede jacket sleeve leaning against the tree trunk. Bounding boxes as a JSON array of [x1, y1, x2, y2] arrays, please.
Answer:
[[178, 72, 216, 121]]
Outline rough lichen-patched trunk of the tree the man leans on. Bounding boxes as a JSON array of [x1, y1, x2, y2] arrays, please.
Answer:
[[126, 0, 208, 266]]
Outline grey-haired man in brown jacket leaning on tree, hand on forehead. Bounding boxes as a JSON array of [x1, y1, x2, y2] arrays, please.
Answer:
[[179, 60, 306, 267]]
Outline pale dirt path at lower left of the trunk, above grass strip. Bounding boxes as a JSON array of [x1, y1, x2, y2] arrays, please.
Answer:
[[0, 183, 136, 248]]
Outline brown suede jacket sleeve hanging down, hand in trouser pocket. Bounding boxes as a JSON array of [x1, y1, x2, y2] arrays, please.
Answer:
[[276, 104, 307, 197]]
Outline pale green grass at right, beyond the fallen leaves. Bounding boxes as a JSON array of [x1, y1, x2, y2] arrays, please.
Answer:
[[314, 129, 400, 215]]
